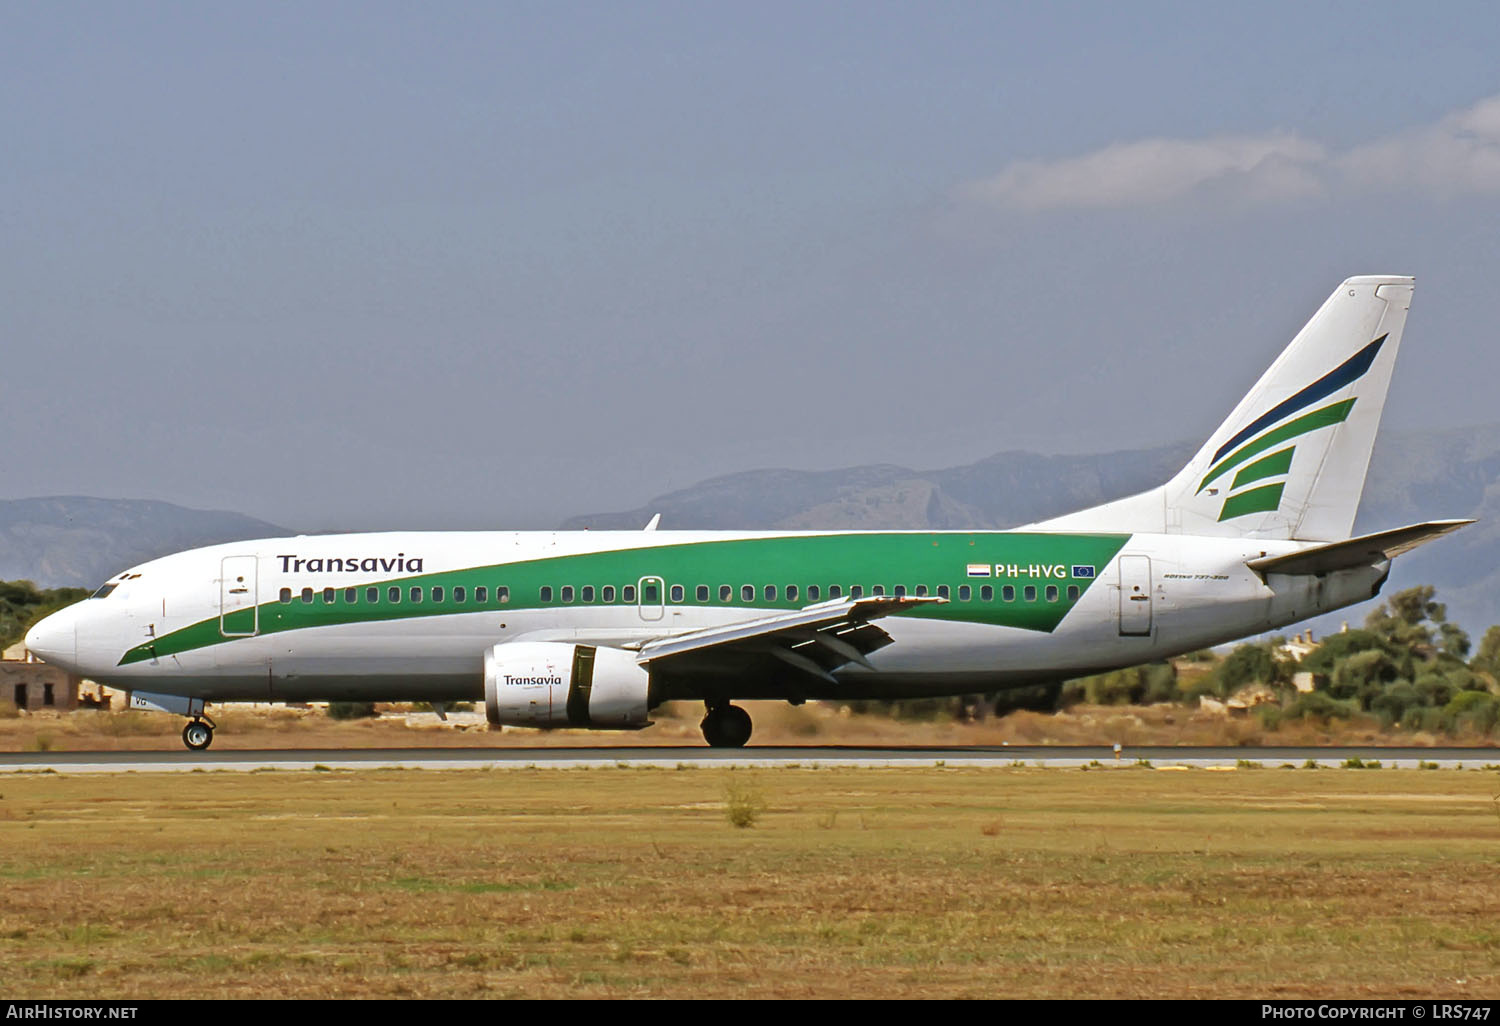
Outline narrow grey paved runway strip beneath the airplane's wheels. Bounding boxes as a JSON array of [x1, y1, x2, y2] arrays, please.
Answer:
[[0, 746, 1500, 773]]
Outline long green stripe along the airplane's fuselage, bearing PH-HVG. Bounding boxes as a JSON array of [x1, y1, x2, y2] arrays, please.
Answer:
[[120, 533, 1130, 665]]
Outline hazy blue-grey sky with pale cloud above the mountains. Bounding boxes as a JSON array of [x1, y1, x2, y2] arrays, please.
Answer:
[[0, 0, 1500, 530]]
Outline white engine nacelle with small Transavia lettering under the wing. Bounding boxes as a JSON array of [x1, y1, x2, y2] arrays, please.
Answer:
[[485, 642, 651, 731]]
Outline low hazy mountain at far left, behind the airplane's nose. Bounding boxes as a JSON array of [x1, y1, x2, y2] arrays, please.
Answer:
[[0, 495, 291, 588]]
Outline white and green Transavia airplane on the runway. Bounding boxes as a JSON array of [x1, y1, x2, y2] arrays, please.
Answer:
[[26, 276, 1473, 750]]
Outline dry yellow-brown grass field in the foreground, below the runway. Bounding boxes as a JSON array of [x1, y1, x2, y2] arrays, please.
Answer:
[[0, 767, 1500, 998]]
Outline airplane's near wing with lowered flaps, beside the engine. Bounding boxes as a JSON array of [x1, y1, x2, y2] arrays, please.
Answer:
[[636, 596, 948, 684]]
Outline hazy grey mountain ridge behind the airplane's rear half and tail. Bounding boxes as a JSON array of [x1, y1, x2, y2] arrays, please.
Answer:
[[564, 425, 1500, 641]]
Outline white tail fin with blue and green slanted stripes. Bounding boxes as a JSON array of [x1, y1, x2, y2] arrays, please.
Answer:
[[1034, 275, 1413, 542]]
